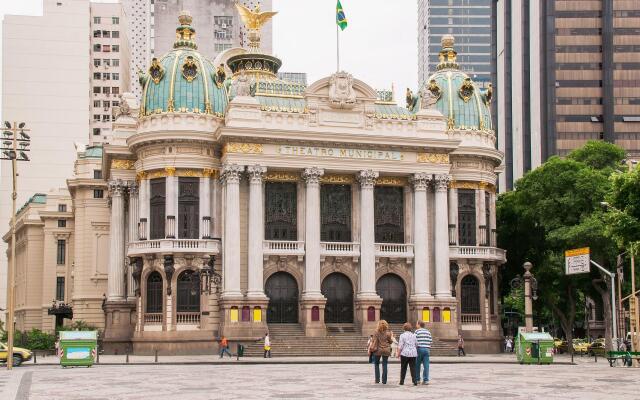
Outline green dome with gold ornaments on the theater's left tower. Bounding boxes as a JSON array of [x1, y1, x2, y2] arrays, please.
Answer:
[[139, 12, 228, 117]]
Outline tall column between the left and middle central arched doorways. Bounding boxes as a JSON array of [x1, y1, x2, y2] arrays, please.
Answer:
[[302, 167, 324, 299]]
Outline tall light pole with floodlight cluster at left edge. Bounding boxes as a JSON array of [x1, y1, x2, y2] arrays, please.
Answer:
[[0, 121, 31, 369]]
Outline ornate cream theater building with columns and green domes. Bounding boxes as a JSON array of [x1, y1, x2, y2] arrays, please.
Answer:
[[5, 8, 505, 353]]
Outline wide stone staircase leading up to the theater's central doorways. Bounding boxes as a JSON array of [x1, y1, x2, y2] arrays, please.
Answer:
[[244, 324, 457, 359]]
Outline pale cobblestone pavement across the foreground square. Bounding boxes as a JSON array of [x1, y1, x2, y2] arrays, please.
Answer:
[[0, 360, 640, 400]]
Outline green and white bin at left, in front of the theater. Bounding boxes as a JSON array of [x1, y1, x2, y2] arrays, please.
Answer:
[[59, 331, 98, 367]]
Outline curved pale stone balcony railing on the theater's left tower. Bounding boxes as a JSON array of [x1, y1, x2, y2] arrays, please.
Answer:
[[127, 239, 220, 257]]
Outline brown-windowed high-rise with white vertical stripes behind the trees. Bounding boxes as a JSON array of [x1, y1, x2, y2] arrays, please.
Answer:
[[492, 0, 640, 191]]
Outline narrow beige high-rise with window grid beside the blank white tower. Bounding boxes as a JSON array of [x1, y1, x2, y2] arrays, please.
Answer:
[[89, 2, 135, 144]]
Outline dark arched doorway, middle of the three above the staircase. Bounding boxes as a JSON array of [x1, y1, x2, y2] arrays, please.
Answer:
[[322, 272, 353, 323]]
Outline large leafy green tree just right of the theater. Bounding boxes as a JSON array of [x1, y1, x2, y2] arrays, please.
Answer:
[[497, 141, 624, 350]]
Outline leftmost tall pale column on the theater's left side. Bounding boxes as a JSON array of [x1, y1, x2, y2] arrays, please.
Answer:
[[107, 180, 126, 301]]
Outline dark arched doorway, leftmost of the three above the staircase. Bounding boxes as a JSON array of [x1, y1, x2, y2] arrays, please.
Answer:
[[265, 272, 298, 324]]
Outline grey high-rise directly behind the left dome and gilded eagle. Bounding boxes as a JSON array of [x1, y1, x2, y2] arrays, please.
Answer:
[[151, 0, 273, 60]]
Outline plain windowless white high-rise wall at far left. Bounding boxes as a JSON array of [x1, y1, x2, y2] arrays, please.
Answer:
[[0, 0, 92, 317]]
